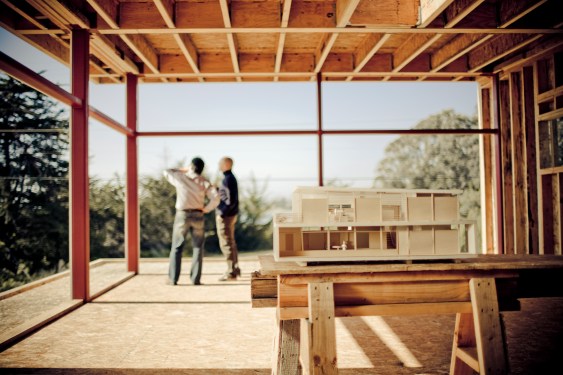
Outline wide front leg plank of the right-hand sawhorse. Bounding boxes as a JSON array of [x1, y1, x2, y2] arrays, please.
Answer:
[[469, 278, 508, 374]]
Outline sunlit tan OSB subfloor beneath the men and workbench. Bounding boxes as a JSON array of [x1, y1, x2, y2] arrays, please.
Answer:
[[0, 257, 563, 375]]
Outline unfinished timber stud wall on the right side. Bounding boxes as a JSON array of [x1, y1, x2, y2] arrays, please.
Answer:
[[480, 48, 563, 255]]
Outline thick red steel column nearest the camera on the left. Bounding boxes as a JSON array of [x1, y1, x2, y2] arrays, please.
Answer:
[[69, 29, 90, 301]]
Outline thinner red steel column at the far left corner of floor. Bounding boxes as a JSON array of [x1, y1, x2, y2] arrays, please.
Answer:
[[125, 74, 140, 273]]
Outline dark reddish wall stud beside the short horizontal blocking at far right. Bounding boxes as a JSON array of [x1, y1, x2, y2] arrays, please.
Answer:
[[522, 66, 540, 254]]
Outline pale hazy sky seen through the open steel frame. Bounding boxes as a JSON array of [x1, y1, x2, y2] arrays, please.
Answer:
[[0, 28, 477, 198]]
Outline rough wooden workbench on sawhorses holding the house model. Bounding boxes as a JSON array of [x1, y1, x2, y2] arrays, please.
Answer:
[[251, 255, 563, 375]]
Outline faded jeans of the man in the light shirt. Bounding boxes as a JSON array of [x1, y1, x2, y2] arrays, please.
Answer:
[[168, 210, 205, 285]]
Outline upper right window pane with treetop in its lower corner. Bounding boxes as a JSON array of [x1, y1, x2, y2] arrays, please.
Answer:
[[322, 82, 478, 130]]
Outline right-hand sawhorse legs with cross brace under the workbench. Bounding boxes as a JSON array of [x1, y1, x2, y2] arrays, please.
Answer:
[[450, 278, 508, 375]]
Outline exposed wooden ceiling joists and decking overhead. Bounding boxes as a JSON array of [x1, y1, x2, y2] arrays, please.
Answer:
[[0, 0, 563, 83]]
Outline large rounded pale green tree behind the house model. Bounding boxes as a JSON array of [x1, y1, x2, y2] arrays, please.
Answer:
[[374, 110, 480, 219]]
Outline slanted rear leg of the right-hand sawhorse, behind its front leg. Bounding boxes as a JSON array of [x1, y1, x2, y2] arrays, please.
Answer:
[[450, 311, 479, 375]]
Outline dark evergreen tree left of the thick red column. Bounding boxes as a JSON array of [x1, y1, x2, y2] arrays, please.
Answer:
[[0, 76, 68, 289]]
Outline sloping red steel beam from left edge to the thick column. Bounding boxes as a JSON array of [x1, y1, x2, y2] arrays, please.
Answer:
[[0, 52, 82, 107]]
